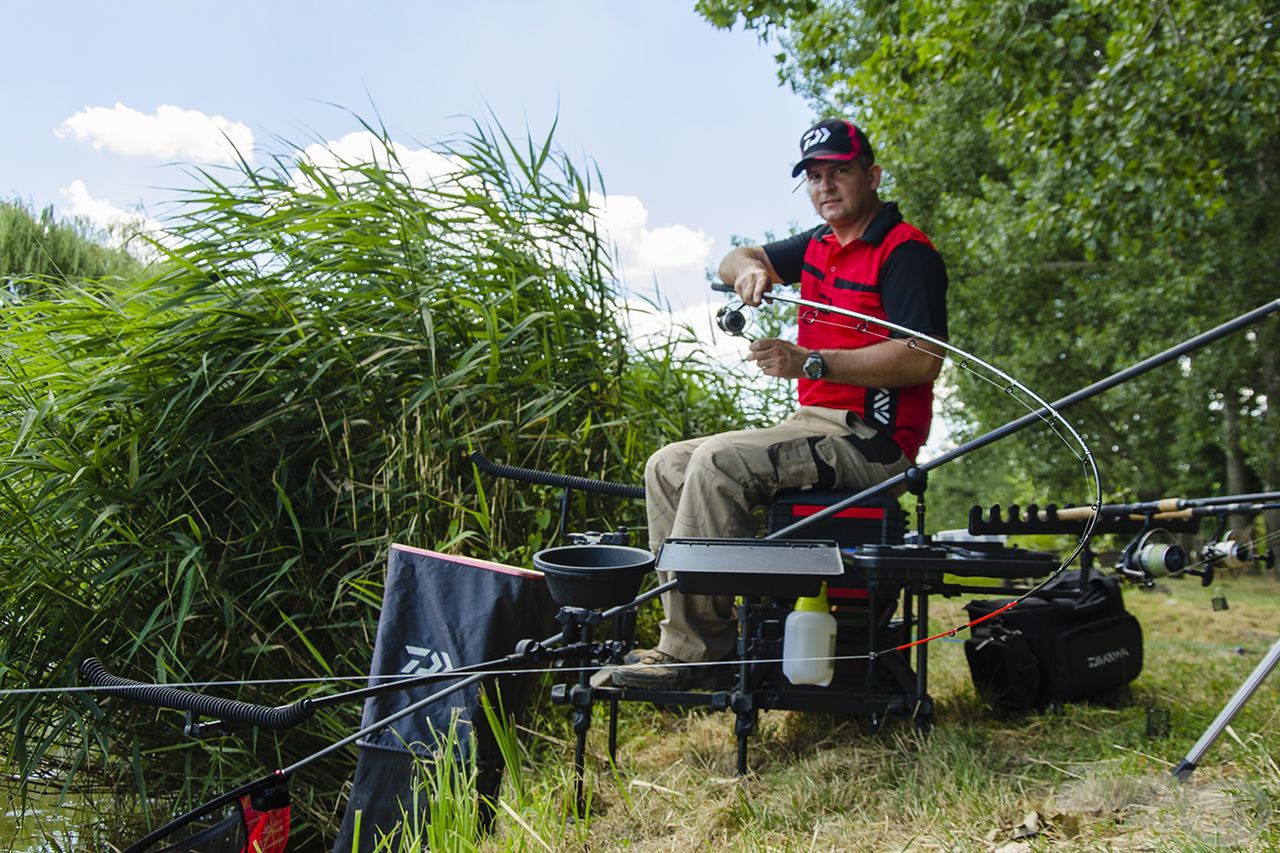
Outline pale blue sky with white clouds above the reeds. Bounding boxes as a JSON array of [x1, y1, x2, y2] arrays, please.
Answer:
[[0, 0, 817, 334]]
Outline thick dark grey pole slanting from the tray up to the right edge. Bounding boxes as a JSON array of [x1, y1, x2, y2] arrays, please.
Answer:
[[764, 300, 1280, 539]]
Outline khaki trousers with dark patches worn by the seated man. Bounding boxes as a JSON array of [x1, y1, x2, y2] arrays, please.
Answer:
[[644, 406, 910, 661]]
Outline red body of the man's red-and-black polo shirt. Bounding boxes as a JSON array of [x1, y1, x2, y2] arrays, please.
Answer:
[[796, 222, 933, 460]]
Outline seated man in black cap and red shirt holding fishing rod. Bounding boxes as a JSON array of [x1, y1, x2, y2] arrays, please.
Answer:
[[612, 119, 947, 689]]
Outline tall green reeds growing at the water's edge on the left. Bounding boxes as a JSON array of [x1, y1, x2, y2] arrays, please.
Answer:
[[0, 116, 737, 834]]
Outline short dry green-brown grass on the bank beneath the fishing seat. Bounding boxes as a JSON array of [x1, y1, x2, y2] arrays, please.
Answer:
[[424, 568, 1280, 850]]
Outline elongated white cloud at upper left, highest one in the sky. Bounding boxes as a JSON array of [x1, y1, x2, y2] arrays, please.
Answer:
[[54, 102, 253, 163]]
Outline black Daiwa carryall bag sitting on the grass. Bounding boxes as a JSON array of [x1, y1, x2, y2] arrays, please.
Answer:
[[964, 573, 1142, 712]]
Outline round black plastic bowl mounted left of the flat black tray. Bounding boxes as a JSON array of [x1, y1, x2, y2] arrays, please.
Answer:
[[534, 544, 653, 610]]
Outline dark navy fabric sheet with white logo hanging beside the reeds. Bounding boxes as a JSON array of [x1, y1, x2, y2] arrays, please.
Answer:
[[334, 544, 556, 853]]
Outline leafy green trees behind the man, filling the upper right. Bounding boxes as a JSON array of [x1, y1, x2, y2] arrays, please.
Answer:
[[699, 0, 1280, 529]]
